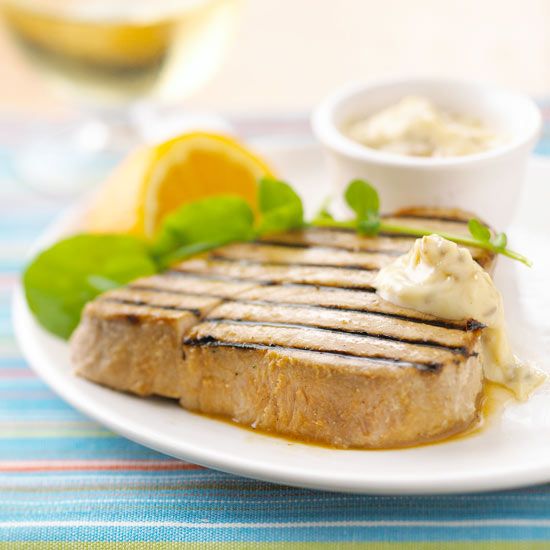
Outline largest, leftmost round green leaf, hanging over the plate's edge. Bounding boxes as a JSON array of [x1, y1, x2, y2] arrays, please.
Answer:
[[23, 235, 157, 338]]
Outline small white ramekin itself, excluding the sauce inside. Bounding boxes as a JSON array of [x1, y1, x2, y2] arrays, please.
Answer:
[[312, 78, 542, 229]]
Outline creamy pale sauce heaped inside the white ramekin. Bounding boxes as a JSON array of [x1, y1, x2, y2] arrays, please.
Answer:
[[346, 96, 502, 157]]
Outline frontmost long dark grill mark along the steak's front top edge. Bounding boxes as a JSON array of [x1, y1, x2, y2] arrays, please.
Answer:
[[183, 336, 443, 372]]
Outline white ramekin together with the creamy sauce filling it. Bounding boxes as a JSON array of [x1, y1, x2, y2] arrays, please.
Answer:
[[312, 78, 542, 229]]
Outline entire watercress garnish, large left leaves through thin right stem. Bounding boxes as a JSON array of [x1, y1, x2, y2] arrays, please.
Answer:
[[23, 179, 531, 338]]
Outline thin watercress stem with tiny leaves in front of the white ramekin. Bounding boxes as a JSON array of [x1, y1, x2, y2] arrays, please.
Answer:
[[312, 180, 533, 267]]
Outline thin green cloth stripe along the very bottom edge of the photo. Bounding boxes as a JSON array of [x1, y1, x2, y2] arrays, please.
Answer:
[[0, 541, 549, 550]]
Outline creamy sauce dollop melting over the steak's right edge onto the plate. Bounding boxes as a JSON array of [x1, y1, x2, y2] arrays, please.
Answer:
[[374, 235, 546, 400]]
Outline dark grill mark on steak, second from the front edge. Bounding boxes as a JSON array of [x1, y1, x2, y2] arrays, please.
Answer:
[[205, 317, 477, 357]]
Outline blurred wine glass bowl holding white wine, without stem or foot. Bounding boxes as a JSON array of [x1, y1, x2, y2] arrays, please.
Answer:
[[0, 0, 240, 105]]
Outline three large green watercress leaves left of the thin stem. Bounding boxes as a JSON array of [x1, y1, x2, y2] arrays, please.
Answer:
[[23, 179, 304, 338]]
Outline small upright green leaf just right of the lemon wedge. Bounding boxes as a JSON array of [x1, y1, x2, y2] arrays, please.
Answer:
[[258, 178, 304, 235]]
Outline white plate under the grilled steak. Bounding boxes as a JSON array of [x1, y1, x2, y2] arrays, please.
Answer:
[[10, 142, 550, 494]]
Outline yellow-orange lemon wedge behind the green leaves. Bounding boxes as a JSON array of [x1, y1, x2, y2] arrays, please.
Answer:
[[85, 132, 273, 238]]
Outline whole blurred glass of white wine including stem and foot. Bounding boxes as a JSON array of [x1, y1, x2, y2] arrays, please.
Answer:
[[0, 0, 241, 194]]
